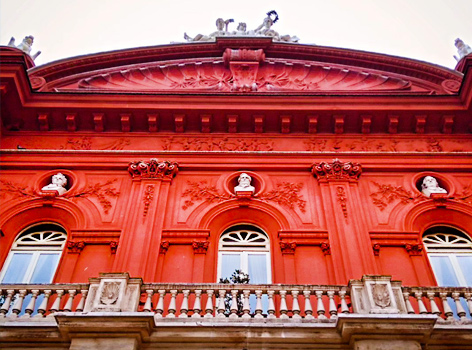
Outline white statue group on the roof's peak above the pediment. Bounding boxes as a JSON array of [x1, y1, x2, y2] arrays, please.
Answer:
[[184, 11, 300, 43]]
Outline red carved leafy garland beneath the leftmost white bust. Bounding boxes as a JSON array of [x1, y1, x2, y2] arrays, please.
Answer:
[[0, 179, 120, 214]]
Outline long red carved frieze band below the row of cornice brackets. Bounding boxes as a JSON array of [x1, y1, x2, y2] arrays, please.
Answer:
[[2, 136, 472, 154]]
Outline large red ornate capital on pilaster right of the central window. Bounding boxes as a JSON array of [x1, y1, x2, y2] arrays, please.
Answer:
[[311, 159, 362, 181]]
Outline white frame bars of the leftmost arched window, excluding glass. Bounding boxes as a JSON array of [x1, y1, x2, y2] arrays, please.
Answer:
[[0, 222, 67, 283]]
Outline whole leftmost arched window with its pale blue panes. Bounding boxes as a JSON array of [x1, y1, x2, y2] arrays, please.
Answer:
[[0, 223, 67, 283]]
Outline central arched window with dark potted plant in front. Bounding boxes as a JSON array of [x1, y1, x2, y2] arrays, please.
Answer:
[[218, 225, 272, 284]]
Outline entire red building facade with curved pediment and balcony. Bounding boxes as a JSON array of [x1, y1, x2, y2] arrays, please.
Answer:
[[0, 38, 472, 349]]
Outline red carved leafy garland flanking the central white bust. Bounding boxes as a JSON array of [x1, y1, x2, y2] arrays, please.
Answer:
[[182, 181, 306, 213]]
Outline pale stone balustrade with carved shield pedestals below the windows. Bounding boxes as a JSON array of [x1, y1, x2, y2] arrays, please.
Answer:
[[0, 274, 472, 324]]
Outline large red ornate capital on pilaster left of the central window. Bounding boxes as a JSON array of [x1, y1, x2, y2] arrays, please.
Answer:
[[128, 158, 179, 181]]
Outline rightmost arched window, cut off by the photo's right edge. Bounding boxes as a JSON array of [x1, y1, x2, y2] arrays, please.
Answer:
[[423, 226, 472, 287]]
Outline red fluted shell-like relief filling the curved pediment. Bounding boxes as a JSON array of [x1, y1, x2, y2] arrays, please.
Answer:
[[79, 59, 411, 92]]
